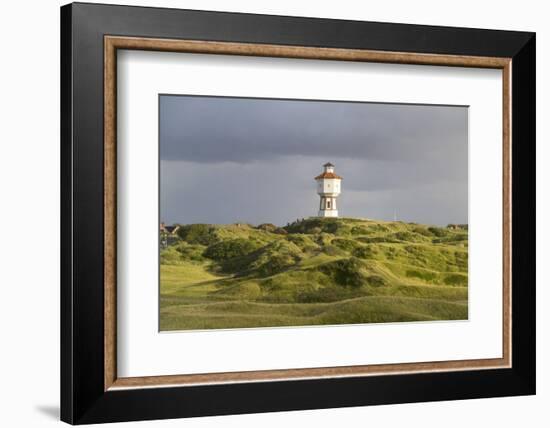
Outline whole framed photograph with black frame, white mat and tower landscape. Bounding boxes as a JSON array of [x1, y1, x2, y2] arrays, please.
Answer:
[[61, 3, 535, 424]]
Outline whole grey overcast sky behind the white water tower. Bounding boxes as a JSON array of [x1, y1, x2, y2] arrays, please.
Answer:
[[160, 95, 468, 225]]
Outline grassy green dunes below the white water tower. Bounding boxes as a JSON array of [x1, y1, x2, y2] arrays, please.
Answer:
[[160, 218, 468, 330]]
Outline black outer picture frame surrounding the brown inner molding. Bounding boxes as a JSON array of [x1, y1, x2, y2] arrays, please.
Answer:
[[61, 3, 536, 424]]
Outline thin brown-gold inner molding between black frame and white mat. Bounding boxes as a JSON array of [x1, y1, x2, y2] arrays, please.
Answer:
[[104, 36, 512, 391]]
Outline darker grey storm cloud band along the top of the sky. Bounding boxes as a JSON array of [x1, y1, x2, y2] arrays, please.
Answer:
[[161, 96, 466, 163]]
